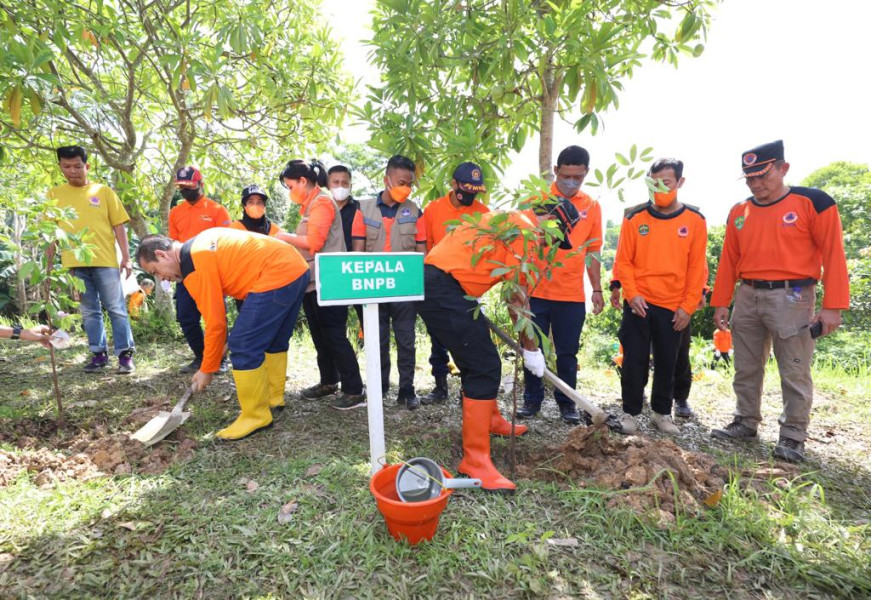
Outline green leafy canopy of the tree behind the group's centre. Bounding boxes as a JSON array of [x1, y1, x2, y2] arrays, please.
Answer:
[[357, 0, 715, 200]]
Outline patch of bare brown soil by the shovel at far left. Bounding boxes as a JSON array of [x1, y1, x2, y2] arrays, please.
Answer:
[[0, 411, 197, 487]]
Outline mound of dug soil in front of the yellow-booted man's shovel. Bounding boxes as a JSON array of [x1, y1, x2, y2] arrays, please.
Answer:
[[0, 431, 196, 487]]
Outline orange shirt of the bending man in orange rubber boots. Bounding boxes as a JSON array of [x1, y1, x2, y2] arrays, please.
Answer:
[[424, 211, 537, 297]]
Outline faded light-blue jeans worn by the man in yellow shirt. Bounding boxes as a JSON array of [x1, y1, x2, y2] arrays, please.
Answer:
[[71, 267, 134, 356]]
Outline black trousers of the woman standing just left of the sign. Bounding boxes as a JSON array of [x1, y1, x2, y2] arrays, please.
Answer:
[[302, 290, 363, 394]]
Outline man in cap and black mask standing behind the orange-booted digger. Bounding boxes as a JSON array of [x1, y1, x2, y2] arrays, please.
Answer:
[[420, 162, 490, 404]]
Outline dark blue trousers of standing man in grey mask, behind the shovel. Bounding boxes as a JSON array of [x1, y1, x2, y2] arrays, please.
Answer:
[[523, 298, 587, 408]]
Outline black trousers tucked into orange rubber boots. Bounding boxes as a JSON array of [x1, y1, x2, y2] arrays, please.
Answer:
[[415, 265, 502, 400]]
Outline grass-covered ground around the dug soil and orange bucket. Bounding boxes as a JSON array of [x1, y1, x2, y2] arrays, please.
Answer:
[[0, 330, 871, 599]]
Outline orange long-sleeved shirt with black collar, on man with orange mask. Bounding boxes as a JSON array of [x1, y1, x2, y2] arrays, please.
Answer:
[[615, 205, 708, 314]]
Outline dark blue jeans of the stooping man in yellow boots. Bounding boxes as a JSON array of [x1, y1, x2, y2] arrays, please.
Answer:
[[227, 271, 309, 371]]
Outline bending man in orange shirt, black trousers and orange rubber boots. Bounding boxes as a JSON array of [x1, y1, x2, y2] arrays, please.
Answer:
[[417, 199, 578, 493]]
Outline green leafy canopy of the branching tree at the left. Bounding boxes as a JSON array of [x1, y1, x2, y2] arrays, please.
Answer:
[[0, 0, 351, 235]]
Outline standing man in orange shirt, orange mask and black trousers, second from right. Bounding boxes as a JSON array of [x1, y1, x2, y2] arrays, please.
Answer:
[[615, 158, 708, 435]]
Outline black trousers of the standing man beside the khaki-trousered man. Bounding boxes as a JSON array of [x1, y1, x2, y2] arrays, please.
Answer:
[[618, 302, 681, 415]]
